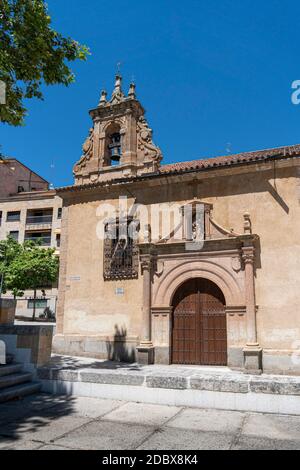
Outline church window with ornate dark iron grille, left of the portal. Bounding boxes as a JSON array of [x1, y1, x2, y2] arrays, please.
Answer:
[[104, 219, 139, 281]]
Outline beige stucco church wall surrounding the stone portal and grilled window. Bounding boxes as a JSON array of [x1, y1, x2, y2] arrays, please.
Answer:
[[59, 159, 300, 370]]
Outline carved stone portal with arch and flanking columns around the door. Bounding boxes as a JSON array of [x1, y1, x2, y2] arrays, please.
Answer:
[[138, 235, 262, 373]]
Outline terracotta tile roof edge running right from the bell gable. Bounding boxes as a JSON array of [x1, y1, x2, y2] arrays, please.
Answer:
[[159, 144, 300, 174]]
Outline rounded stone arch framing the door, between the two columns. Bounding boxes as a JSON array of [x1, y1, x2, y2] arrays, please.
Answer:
[[151, 253, 247, 368]]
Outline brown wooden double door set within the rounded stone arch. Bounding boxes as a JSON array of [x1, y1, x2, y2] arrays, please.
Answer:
[[172, 278, 227, 366]]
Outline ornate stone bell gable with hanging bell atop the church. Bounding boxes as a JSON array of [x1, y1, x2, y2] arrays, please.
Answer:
[[74, 75, 162, 184]]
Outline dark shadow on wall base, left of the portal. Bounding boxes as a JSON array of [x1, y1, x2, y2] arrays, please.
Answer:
[[106, 325, 136, 363]]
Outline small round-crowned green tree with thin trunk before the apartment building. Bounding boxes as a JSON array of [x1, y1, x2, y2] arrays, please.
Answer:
[[6, 241, 59, 320]]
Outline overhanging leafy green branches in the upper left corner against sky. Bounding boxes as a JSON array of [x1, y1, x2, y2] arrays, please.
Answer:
[[0, 0, 89, 126]]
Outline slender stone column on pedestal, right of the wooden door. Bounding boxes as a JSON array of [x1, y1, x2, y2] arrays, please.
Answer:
[[242, 246, 262, 373]]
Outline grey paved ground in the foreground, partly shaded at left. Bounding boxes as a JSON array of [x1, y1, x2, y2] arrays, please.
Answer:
[[0, 394, 300, 450]]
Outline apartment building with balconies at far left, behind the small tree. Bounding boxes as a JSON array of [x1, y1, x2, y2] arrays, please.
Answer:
[[0, 159, 62, 318]]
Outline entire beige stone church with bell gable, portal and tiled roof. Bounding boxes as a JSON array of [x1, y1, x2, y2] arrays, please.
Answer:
[[54, 76, 300, 374]]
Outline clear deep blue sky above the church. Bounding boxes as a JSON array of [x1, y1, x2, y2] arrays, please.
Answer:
[[0, 0, 300, 186]]
